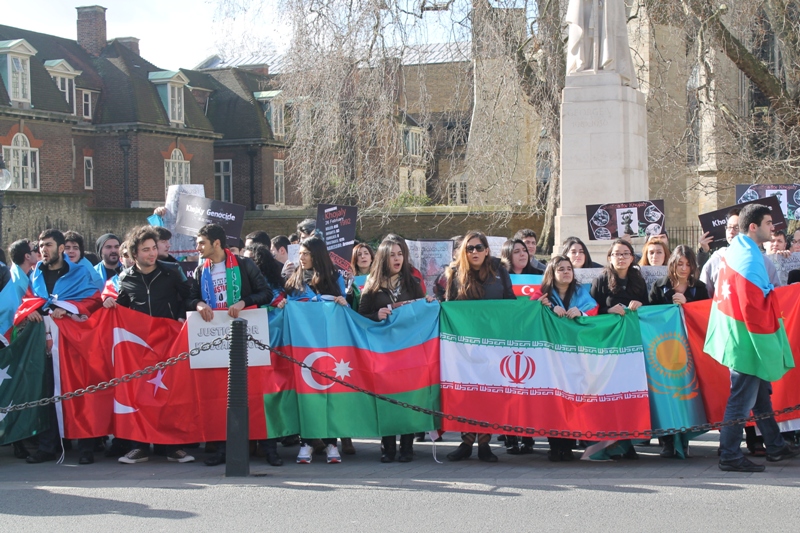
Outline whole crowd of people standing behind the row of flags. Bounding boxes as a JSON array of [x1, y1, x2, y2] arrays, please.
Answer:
[[0, 210, 800, 467]]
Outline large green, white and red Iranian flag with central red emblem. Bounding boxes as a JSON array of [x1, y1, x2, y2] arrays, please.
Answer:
[[440, 300, 650, 432]]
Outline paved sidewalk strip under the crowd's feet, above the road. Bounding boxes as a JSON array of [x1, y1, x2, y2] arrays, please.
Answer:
[[0, 432, 800, 486]]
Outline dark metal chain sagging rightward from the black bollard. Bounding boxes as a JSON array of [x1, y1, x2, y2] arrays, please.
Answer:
[[252, 335, 800, 441]]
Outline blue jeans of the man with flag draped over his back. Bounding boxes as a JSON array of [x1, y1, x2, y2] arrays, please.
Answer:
[[719, 369, 785, 461]]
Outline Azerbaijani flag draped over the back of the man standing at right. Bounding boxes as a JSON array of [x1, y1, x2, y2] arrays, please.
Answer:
[[703, 234, 794, 382]]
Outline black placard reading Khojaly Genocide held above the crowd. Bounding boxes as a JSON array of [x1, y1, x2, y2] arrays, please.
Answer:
[[175, 194, 245, 246]]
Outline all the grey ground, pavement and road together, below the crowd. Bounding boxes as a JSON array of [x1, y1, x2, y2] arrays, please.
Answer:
[[0, 434, 800, 533]]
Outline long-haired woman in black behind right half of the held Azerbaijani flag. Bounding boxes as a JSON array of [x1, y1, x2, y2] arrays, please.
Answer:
[[358, 234, 425, 463]]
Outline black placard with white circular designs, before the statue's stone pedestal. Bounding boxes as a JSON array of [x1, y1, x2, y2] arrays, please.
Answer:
[[586, 200, 665, 241]]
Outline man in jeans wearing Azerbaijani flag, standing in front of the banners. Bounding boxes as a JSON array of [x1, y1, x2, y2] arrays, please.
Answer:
[[703, 204, 800, 472]]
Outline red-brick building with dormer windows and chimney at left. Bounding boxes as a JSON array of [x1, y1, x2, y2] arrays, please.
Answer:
[[0, 2, 288, 220]]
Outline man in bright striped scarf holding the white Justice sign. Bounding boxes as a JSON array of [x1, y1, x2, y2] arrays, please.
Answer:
[[188, 224, 272, 466]]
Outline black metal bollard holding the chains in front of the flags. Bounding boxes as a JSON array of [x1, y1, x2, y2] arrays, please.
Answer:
[[225, 318, 250, 477]]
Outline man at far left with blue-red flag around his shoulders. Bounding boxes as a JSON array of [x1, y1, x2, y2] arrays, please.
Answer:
[[14, 229, 100, 464]]
